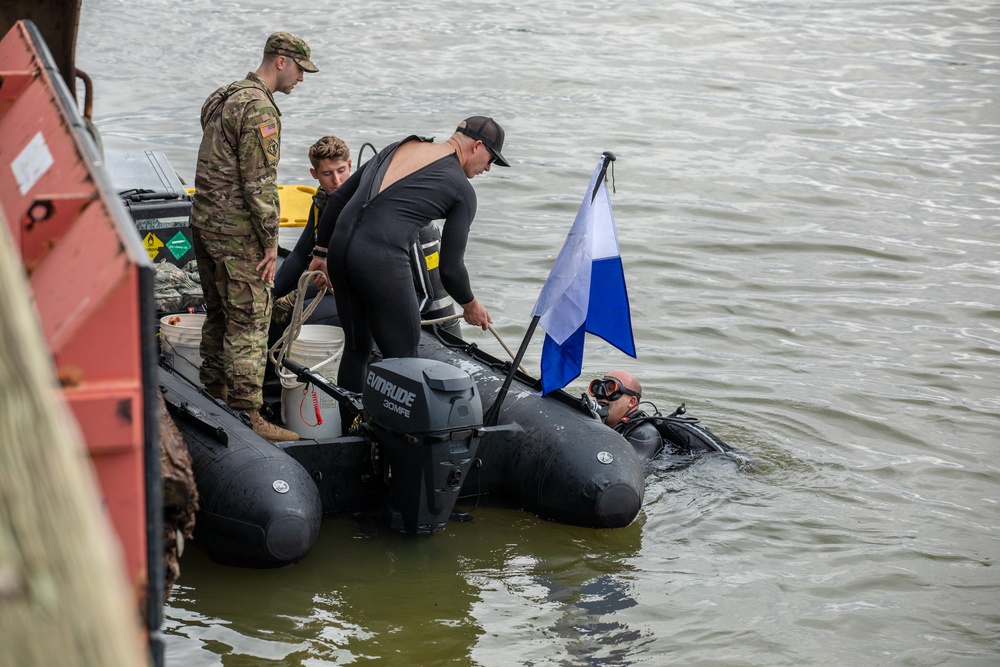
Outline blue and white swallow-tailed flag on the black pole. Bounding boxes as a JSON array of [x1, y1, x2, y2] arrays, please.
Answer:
[[531, 159, 635, 394]]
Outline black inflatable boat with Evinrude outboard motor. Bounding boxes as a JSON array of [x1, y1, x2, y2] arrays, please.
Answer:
[[153, 316, 644, 567]]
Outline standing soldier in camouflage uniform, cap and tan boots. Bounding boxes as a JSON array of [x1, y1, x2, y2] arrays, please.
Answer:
[[191, 32, 319, 441]]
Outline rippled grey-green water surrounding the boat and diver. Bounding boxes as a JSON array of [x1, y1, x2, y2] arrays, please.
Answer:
[[72, 0, 1000, 667]]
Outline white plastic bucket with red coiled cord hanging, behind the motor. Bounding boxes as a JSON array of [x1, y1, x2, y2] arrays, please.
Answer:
[[281, 324, 344, 439]]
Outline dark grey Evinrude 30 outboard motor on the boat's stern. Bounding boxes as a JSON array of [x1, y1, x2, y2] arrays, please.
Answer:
[[363, 358, 483, 533]]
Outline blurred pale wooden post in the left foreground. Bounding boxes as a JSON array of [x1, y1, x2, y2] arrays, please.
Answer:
[[0, 210, 149, 667]]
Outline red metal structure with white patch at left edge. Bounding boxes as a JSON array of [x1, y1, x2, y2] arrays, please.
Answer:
[[0, 21, 163, 662]]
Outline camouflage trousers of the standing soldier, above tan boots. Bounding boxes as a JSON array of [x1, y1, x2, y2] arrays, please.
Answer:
[[191, 228, 271, 410]]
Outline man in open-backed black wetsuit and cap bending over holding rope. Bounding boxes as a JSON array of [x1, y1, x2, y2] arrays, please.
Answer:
[[309, 116, 510, 391]]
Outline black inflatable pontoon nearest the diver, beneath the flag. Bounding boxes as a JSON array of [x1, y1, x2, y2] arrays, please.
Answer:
[[419, 330, 645, 528]]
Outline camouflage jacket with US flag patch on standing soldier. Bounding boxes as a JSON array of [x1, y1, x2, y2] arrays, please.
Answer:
[[191, 72, 281, 248]]
